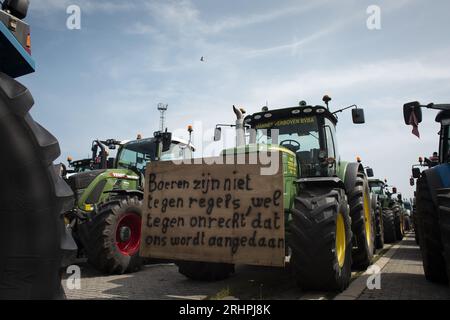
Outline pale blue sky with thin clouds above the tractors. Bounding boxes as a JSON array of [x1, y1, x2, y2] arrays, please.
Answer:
[[17, 0, 450, 196]]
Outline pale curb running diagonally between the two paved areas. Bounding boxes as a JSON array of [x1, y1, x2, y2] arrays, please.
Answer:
[[333, 242, 401, 300]]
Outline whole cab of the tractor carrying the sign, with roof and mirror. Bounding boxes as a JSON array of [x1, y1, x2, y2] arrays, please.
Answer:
[[244, 96, 364, 178]]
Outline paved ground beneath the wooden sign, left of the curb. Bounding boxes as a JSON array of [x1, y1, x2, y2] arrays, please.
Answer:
[[63, 263, 329, 300]]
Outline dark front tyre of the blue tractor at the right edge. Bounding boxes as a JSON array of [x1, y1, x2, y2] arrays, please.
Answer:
[[416, 175, 448, 283]]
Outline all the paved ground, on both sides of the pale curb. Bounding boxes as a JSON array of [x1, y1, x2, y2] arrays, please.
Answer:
[[63, 232, 450, 300]]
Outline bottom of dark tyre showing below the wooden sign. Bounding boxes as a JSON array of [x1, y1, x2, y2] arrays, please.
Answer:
[[176, 261, 234, 281]]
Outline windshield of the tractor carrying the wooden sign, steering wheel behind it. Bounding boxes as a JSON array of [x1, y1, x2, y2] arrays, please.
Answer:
[[255, 117, 322, 177]]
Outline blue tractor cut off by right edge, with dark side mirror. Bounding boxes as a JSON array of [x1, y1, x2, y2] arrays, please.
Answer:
[[403, 102, 450, 283]]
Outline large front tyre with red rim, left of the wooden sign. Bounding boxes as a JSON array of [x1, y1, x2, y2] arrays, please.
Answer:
[[78, 197, 142, 274]]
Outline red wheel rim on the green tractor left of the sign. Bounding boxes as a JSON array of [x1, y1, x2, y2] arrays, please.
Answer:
[[116, 212, 141, 256]]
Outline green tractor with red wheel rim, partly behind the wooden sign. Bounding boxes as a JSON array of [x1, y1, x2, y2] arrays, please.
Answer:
[[66, 129, 194, 274]]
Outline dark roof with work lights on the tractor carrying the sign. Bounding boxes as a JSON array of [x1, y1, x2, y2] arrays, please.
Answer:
[[244, 106, 337, 125]]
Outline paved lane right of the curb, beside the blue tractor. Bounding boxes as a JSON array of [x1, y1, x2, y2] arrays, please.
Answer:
[[359, 234, 450, 300]]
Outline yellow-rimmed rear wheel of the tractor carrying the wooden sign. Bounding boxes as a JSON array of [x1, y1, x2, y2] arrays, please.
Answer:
[[348, 173, 375, 270]]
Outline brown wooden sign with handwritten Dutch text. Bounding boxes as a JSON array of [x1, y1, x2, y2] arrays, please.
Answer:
[[140, 158, 285, 266]]
